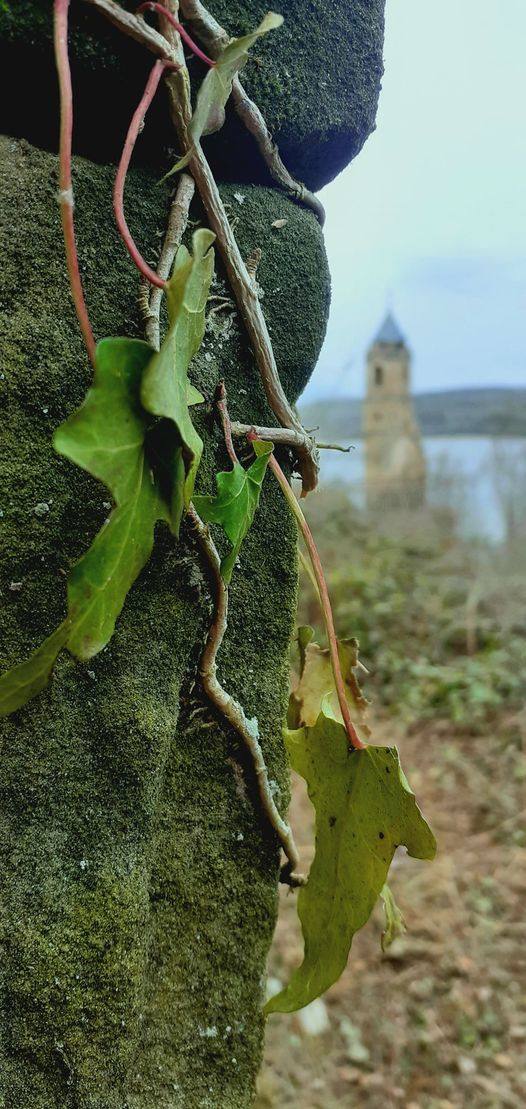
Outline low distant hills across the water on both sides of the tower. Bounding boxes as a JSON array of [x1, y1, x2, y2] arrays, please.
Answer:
[[300, 388, 526, 439]]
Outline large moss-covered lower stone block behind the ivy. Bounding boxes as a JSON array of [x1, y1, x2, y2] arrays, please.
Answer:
[[0, 139, 327, 1109]]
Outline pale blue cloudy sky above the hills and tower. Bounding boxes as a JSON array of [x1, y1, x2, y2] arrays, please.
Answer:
[[305, 0, 526, 399]]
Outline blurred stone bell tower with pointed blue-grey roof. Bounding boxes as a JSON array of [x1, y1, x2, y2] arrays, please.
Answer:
[[363, 313, 426, 510]]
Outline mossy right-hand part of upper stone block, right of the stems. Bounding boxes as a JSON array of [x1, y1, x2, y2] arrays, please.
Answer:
[[209, 0, 385, 189]]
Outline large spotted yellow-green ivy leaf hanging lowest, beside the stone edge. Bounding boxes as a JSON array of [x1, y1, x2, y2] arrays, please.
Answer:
[[266, 702, 436, 1013]]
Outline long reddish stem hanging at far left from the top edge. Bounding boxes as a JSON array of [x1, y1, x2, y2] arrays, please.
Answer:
[[54, 0, 95, 365]]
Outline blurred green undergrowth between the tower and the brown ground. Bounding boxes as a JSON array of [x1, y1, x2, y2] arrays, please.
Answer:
[[300, 487, 526, 732]]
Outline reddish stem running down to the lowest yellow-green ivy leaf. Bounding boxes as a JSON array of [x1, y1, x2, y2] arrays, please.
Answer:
[[258, 433, 365, 749]]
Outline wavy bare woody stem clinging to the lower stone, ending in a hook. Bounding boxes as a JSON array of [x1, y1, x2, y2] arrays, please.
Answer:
[[188, 506, 305, 886]]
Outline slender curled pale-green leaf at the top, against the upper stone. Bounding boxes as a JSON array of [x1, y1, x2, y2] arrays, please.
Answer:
[[163, 11, 283, 181]]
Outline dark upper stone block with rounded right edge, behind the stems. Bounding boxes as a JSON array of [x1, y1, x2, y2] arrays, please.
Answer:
[[0, 0, 385, 189]]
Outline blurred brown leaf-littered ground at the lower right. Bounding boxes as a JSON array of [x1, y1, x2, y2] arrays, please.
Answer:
[[256, 720, 526, 1109]]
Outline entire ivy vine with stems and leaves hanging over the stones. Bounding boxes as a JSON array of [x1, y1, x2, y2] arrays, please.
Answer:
[[0, 0, 436, 1013]]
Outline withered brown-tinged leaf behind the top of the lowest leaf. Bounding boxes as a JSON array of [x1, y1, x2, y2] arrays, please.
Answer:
[[289, 627, 371, 737]]
